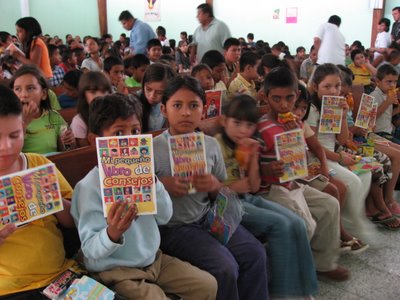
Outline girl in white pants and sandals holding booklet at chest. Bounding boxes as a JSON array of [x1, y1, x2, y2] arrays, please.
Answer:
[[307, 64, 373, 248]]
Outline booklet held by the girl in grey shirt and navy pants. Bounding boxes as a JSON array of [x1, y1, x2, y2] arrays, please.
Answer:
[[168, 132, 207, 194]]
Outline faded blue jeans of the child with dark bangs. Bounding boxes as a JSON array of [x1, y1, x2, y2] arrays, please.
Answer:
[[241, 194, 318, 297]]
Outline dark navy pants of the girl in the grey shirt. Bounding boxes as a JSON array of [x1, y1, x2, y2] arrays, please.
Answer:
[[160, 219, 268, 300]]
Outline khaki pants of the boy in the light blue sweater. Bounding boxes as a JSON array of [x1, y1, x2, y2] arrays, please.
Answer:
[[95, 251, 217, 300]]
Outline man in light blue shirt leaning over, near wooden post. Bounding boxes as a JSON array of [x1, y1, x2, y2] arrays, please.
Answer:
[[119, 10, 157, 54]]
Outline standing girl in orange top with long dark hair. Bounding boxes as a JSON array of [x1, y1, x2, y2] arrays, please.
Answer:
[[9, 17, 53, 78]]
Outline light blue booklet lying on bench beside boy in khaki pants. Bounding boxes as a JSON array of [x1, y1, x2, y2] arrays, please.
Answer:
[[61, 275, 115, 300]]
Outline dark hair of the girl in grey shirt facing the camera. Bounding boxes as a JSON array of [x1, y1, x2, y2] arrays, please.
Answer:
[[162, 75, 206, 105]]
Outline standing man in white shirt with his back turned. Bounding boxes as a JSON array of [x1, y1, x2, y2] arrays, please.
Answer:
[[314, 15, 345, 65]]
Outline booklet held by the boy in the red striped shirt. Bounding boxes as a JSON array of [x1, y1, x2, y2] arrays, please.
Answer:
[[274, 129, 308, 183]]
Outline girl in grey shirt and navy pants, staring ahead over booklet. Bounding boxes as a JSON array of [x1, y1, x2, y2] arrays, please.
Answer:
[[154, 76, 268, 300]]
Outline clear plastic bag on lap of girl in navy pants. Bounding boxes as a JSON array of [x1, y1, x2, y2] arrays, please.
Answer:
[[206, 187, 244, 245]]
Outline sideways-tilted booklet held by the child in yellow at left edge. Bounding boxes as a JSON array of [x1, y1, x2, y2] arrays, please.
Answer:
[[0, 163, 64, 228]]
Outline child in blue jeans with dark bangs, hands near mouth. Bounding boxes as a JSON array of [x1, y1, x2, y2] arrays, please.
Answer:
[[216, 95, 317, 298]]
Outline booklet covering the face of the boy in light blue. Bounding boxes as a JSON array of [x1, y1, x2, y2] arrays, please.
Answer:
[[96, 134, 157, 217]]
